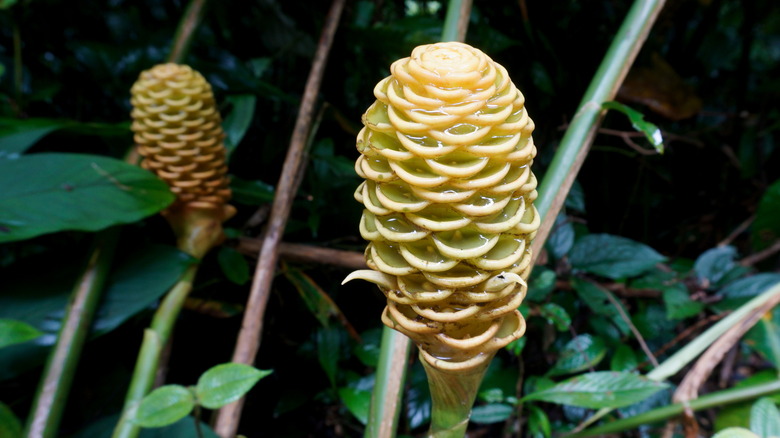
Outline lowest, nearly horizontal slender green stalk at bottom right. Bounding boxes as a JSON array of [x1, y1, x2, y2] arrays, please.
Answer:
[[565, 380, 780, 438]]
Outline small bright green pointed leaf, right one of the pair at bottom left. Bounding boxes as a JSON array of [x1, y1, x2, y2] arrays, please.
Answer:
[[195, 363, 273, 409]]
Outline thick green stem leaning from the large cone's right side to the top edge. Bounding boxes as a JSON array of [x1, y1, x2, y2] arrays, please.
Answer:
[[531, 0, 665, 258]]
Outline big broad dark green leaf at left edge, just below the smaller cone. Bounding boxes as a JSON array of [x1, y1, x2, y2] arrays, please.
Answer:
[[0, 153, 174, 242]]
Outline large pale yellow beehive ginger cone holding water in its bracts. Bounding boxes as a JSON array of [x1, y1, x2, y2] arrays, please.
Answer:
[[347, 42, 539, 373]]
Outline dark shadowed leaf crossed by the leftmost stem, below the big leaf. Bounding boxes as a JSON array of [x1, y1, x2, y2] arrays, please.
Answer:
[[0, 245, 192, 381]]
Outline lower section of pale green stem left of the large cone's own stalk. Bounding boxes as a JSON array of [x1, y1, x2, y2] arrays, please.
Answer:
[[364, 327, 412, 438]]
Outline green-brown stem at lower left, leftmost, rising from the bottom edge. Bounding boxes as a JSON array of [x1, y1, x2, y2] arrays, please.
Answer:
[[25, 228, 119, 438]]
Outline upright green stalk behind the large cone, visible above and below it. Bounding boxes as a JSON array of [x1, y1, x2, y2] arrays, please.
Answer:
[[364, 0, 476, 438]]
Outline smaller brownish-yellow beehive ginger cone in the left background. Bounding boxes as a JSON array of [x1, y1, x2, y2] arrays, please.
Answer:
[[130, 63, 235, 258]]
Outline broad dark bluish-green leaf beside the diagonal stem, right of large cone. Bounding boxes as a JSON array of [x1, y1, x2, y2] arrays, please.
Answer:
[[569, 234, 666, 279]]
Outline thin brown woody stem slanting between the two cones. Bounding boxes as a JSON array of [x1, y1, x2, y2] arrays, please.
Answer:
[[215, 0, 345, 438]]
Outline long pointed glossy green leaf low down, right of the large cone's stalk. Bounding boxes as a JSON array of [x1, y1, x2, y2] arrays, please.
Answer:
[[522, 371, 668, 409]]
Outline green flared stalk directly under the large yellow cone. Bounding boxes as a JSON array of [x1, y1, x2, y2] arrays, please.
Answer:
[[420, 355, 492, 438]]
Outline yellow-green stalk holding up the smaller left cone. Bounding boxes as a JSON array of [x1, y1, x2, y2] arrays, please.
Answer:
[[112, 264, 199, 438]]
